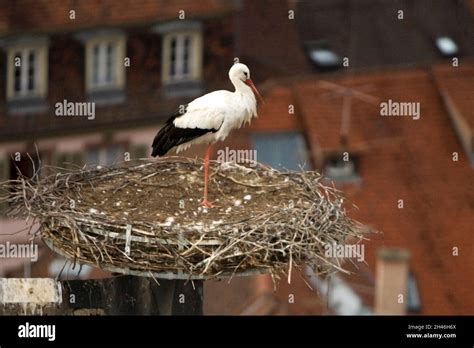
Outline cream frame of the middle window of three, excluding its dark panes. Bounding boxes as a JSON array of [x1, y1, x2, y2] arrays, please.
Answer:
[[80, 32, 126, 93]]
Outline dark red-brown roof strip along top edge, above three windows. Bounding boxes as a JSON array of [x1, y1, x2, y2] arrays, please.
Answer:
[[0, 0, 235, 33]]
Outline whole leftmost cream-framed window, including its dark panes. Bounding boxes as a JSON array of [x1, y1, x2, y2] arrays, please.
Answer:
[[6, 39, 48, 106]]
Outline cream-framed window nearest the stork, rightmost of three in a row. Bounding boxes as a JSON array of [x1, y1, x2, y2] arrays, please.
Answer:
[[153, 21, 203, 96]]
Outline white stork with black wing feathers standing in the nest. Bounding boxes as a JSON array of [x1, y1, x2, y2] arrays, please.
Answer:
[[151, 63, 263, 208]]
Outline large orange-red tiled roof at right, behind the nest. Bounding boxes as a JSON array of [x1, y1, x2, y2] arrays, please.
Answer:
[[254, 64, 474, 314]]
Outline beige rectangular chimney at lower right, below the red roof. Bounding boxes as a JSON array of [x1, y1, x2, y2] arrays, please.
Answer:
[[375, 248, 410, 315]]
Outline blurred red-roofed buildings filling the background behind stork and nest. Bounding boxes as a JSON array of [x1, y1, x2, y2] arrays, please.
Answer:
[[0, 0, 474, 314]]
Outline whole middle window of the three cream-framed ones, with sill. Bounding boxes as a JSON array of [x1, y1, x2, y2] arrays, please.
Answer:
[[77, 29, 126, 104]]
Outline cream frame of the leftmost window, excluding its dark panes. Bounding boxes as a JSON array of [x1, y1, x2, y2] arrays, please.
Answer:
[[7, 41, 48, 100]]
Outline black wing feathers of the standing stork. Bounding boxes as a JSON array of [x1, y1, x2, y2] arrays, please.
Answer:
[[151, 105, 218, 157]]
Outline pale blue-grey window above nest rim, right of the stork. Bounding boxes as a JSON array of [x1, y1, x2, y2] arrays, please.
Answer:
[[252, 132, 311, 170]]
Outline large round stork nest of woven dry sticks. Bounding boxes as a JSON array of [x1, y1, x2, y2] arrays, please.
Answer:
[[0, 157, 363, 279]]
